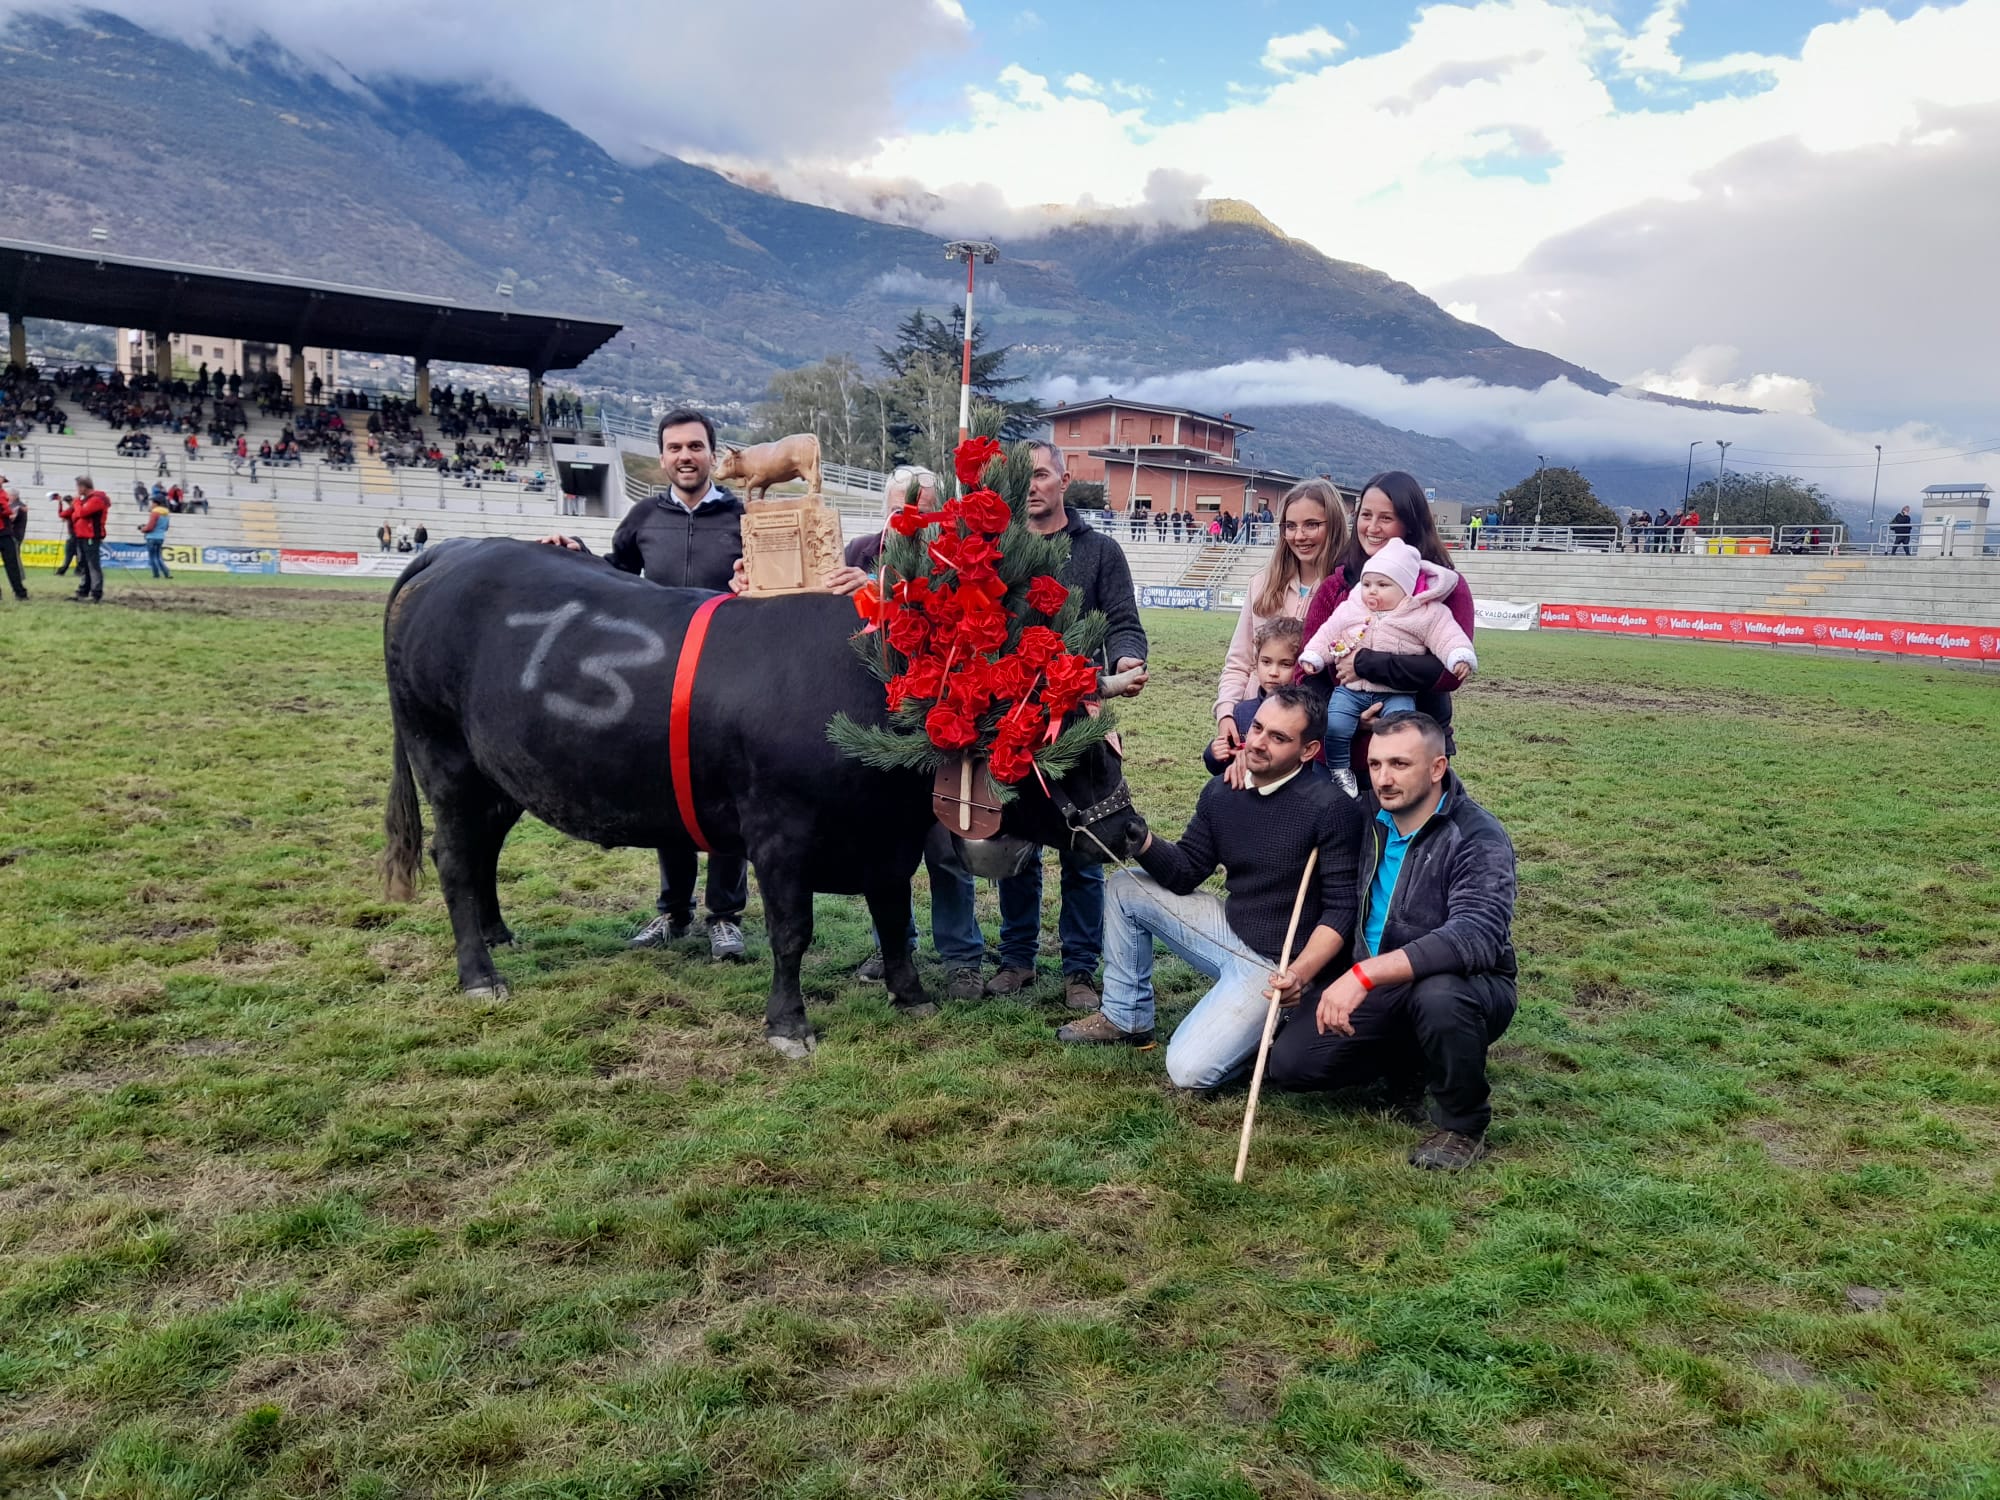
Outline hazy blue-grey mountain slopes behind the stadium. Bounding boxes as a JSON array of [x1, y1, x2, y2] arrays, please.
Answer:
[[0, 14, 1610, 488]]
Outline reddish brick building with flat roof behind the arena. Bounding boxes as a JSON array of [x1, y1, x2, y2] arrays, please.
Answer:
[[1048, 396, 1300, 520]]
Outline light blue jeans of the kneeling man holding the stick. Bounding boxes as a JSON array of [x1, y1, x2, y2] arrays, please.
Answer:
[[1104, 870, 1276, 1088]]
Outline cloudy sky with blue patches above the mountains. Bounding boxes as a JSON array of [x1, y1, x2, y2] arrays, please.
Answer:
[[35, 0, 2000, 506]]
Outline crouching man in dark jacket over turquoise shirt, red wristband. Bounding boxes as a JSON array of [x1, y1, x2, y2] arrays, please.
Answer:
[[1266, 714, 1514, 1172]]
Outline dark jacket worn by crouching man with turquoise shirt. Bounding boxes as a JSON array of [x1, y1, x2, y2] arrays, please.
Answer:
[[1354, 772, 1514, 978]]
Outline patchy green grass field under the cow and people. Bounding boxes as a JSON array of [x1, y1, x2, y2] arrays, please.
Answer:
[[0, 574, 2000, 1500]]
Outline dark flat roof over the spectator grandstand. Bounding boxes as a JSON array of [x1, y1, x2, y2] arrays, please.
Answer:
[[0, 240, 622, 374]]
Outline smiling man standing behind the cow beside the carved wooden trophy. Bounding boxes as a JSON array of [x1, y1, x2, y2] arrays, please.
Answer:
[[542, 410, 750, 958]]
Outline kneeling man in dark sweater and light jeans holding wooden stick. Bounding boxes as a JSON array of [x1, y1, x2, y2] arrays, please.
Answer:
[[1056, 688, 1362, 1088]]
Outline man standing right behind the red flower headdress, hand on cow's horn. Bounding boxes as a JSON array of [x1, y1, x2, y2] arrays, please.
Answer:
[[986, 442, 1146, 1010]]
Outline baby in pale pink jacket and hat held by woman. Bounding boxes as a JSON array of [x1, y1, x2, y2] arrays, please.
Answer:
[[1298, 536, 1480, 794]]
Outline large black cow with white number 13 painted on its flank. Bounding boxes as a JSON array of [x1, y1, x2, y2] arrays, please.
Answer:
[[382, 538, 1146, 1058]]
